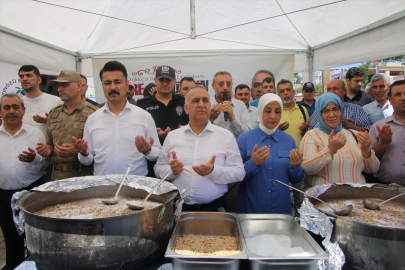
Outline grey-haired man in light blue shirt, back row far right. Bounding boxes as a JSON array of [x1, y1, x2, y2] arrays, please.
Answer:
[[363, 73, 394, 125]]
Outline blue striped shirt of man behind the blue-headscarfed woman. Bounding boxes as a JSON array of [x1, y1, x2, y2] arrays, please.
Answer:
[[308, 102, 371, 130]]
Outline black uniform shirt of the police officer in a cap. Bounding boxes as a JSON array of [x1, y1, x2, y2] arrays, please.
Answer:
[[136, 93, 188, 145]]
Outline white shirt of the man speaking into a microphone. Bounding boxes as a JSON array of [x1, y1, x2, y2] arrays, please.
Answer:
[[210, 97, 252, 138]]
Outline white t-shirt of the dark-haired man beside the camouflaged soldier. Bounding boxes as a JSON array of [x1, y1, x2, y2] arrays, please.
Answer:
[[22, 93, 63, 137]]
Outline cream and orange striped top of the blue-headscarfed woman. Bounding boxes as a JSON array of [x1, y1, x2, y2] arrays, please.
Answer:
[[300, 128, 380, 186]]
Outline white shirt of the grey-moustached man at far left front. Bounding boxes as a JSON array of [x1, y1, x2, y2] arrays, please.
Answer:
[[0, 124, 45, 190]]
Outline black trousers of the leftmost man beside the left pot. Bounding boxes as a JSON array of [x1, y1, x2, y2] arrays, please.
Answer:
[[0, 177, 44, 270]]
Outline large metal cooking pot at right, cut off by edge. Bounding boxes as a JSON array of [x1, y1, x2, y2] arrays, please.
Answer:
[[307, 185, 405, 270]]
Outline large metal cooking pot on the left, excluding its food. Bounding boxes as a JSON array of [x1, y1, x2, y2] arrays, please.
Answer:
[[18, 182, 179, 270]]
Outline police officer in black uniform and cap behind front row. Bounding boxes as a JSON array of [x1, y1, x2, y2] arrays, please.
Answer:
[[137, 65, 188, 177]]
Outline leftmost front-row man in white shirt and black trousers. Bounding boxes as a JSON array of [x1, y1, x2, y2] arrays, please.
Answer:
[[0, 93, 45, 269]]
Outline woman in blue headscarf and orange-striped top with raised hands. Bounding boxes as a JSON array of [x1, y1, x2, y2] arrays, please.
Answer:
[[300, 93, 380, 186]]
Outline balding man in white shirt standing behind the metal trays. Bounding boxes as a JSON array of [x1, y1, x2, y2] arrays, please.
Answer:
[[155, 85, 245, 211]]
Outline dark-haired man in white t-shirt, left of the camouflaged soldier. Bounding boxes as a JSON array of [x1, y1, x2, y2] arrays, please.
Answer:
[[18, 65, 63, 182]]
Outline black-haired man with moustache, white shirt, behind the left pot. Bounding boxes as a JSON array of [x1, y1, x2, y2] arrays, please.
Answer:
[[75, 61, 162, 175]]
